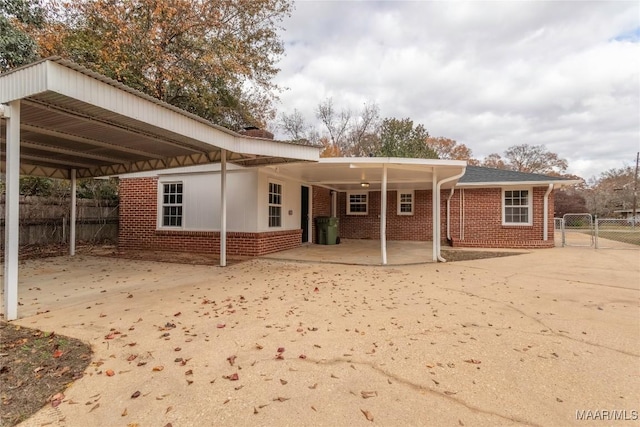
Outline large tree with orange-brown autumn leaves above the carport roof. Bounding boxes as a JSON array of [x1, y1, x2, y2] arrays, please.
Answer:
[[35, 0, 291, 129]]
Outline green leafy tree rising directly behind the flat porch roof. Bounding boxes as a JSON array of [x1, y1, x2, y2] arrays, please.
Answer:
[[376, 118, 438, 159]]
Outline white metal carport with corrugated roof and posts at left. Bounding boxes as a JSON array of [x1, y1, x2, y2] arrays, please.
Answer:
[[0, 57, 319, 320]]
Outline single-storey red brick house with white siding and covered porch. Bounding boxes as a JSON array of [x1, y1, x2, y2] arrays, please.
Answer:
[[119, 158, 573, 263]]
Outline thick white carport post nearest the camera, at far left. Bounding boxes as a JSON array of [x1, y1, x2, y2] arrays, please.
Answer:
[[4, 101, 20, 320]]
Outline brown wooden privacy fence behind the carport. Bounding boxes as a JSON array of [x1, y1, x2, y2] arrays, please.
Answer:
[[0, 196, 118, 248]]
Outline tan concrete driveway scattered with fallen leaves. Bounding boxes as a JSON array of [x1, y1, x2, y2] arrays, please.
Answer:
[[2, 248, 640, 426]]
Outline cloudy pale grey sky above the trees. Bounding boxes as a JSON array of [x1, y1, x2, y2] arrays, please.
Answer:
[[276, 0, 640, 179]]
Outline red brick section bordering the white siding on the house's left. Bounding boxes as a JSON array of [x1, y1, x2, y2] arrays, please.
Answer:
[[118, 178, 302, 256]]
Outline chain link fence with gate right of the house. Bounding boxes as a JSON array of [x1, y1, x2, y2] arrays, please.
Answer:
[[554, 213, 640, 249]]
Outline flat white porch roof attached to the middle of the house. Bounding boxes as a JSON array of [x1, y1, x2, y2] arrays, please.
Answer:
[[268, 157, 467, 191]]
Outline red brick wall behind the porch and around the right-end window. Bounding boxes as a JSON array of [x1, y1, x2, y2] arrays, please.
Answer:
[[306, 187, 554, 248]]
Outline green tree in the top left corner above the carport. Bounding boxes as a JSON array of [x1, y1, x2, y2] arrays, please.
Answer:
[[0, 0, 44, 72]]
